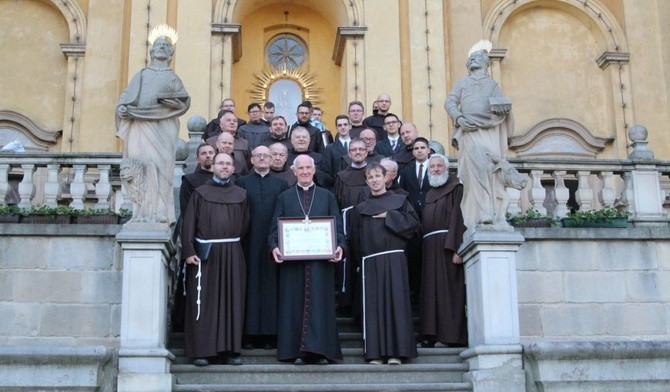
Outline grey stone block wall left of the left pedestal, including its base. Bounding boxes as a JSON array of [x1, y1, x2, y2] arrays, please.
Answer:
[[0, 224, 122, 390]]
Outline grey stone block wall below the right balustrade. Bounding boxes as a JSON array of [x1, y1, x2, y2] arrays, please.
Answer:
[[517, 228, 670, 343]]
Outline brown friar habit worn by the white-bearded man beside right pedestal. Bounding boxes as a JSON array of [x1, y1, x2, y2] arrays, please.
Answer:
[[421, 174, 468, 345]]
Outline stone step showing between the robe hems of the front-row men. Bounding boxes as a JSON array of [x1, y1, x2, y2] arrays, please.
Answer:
[[170, 347, 463, 365]]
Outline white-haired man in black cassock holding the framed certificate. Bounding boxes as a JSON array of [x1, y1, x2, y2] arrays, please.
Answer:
[[268, 155, 345, 364]]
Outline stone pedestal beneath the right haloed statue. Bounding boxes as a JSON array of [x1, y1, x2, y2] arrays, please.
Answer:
[[460, 231, 526, 392]]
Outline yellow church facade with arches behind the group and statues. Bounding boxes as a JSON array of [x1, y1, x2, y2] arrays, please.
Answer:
[[0, 0, 670, 159]]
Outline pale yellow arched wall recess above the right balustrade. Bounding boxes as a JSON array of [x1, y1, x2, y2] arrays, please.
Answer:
[[499, 8, 614, 137]]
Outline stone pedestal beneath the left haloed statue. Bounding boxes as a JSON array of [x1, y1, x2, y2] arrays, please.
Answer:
[[116, 223, 174, 392]]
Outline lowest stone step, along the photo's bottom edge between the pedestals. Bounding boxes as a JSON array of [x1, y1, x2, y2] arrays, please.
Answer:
[[172, 382, 472, 392]]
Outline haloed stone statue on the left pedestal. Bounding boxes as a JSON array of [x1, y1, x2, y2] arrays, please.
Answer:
[[116, 25, 191, 223]]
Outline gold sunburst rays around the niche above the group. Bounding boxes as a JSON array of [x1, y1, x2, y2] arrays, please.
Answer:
[[252, 69, 323, 104]]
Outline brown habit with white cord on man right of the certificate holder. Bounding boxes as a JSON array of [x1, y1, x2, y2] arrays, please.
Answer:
[[351, 192, 419, 360]]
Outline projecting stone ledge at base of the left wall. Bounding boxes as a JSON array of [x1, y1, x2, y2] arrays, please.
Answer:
[[0, 346, 114, 391]]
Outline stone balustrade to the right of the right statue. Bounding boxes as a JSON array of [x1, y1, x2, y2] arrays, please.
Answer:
[[507, 158, 670, 223]]
